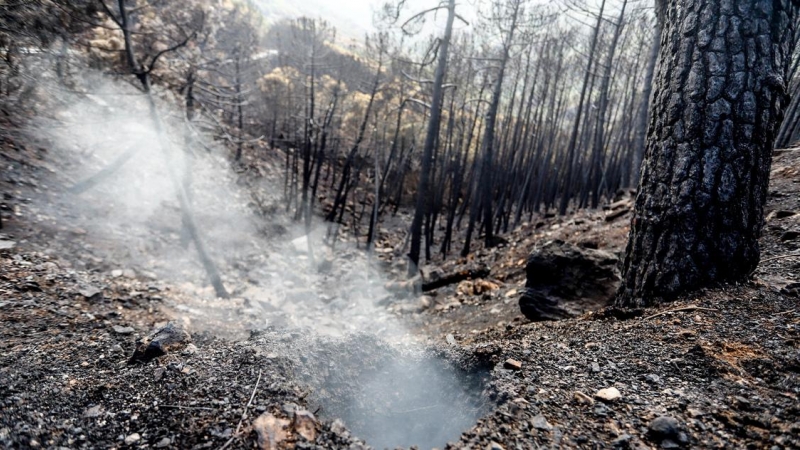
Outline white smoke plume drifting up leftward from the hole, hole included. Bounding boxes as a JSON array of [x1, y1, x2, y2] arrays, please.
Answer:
[[18, 62, 488, 448]]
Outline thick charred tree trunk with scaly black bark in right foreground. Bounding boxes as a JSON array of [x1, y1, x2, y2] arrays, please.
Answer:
[[617, 0, 797, 307]]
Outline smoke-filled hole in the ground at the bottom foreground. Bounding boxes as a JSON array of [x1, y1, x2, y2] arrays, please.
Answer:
[[312, 342, 490, 449]]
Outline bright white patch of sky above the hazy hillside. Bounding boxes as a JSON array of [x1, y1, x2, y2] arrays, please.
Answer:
[[252, 0, 378, 39]]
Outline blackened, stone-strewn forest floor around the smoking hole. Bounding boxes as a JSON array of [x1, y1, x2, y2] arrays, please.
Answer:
[[0, 142, 800, 449]]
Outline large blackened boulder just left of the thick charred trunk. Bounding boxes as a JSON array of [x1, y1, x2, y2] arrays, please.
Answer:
[[519, 240, 620, 321]]
